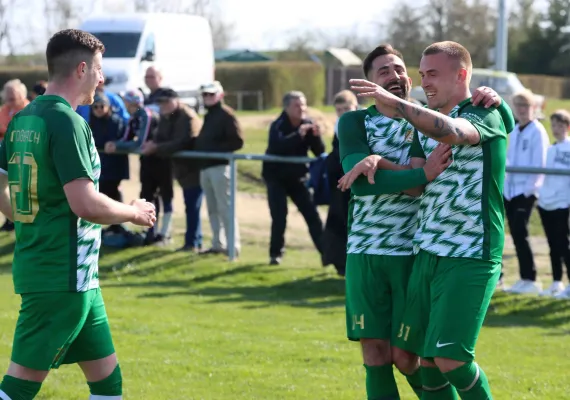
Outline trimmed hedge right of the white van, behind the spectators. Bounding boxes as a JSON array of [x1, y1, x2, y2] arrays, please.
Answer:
[[216, 62, 325, 110]]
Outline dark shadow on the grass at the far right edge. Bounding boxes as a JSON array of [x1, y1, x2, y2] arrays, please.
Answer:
[[485, 292, 570, 328]]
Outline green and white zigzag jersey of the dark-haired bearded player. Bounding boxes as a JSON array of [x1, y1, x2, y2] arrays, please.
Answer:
[[339, 106, 420, 256]]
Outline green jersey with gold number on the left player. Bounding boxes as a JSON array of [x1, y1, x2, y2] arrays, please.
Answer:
[[0, 95, 101, 294]]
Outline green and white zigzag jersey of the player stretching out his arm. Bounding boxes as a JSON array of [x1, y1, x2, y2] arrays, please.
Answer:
[[410, 99, 507, 261]]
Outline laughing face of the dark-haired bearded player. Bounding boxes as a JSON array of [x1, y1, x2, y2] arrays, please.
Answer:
[[367, 54, 412, 100]]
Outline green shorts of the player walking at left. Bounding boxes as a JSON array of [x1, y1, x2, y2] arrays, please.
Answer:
[[12, 288, 115, 371]]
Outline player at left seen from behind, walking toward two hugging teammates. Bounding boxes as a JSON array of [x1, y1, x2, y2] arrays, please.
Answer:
[[0, 29, 155, 400]]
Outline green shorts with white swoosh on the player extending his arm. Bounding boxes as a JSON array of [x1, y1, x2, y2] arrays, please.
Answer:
[[394, 250, 501, 362]]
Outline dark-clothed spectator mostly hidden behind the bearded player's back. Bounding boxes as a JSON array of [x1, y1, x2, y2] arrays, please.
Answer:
[[322, 90, 358, 276]]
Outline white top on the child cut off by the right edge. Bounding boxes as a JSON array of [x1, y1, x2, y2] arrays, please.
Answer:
[[538, 138, 570, 211]]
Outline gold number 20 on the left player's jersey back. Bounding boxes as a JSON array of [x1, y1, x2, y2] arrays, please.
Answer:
[[8, 152, 38, 224]]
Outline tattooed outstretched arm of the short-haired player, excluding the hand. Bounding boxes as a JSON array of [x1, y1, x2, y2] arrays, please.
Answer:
[[390, 99, 481, 145]]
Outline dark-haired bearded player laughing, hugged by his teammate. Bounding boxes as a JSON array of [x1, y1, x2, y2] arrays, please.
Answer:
[[338, 45, 500, 400]]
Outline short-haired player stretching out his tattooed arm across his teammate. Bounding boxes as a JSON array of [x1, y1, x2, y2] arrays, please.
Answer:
[[350, 42, 512, 400]]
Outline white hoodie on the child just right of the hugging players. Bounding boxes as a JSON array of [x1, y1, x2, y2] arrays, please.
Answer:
[[504, 120, 550, 200]]
